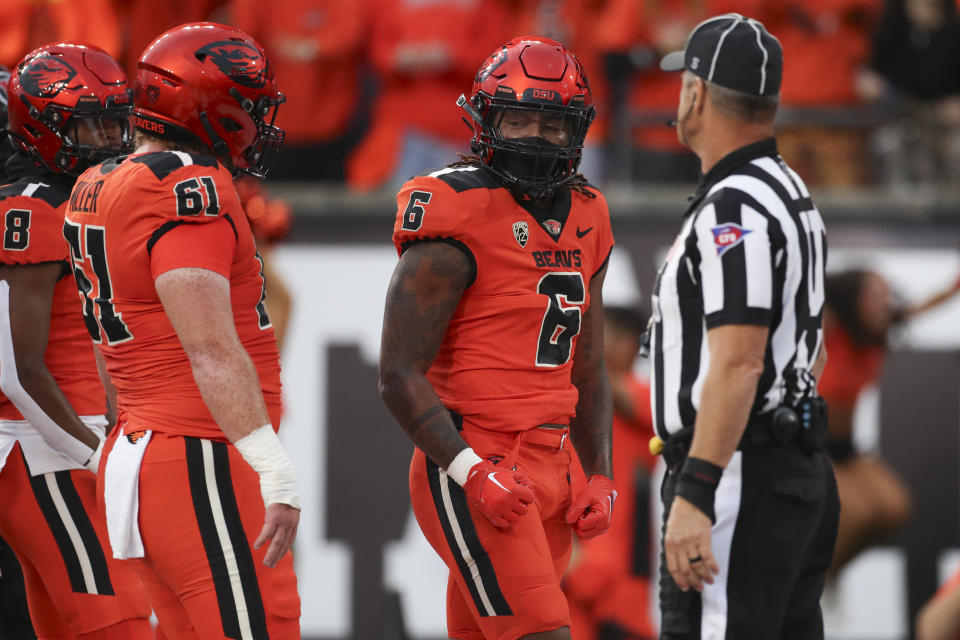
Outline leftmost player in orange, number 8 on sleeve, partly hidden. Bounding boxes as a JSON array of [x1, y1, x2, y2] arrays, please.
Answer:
[[0, 42, 153, 640]]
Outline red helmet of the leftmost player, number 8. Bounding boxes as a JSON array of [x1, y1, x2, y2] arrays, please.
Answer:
[[7, 42, 133, 175]]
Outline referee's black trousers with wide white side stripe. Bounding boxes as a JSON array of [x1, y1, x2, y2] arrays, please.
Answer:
[[660, 443, 840, 640]]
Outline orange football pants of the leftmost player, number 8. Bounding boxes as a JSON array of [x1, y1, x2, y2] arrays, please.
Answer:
[[0, 444, 153, 640]]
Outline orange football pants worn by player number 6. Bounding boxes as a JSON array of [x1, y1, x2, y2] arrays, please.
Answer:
[[410, 426, 572, 640]]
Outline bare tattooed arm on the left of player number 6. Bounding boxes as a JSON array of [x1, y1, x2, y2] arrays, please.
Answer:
[[380, 241, 472, 468]]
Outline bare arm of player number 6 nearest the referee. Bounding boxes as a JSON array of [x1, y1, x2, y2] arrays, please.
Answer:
[[570, 266, 613, 478]]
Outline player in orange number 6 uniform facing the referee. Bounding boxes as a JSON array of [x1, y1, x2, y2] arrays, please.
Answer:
[[380, 37, 615, 640]]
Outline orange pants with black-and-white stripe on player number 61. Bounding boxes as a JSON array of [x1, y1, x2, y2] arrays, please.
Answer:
[[97, 429, 300, 640]]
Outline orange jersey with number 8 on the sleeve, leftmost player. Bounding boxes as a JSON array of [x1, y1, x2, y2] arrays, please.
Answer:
[[0, 175, 105, 420]]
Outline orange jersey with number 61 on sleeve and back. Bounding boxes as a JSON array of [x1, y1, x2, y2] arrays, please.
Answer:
[[64, 151, 280, 439]]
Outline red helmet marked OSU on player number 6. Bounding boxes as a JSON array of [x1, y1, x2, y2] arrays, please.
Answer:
[[458, 36, 595, 198]]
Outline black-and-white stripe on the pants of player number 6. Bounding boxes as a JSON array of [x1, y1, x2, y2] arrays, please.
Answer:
[[426, 457, 513, 617]]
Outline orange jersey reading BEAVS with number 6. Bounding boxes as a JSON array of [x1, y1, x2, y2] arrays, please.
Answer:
[[393, 167, 613, 431]]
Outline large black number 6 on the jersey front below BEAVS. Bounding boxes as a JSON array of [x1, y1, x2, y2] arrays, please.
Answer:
[[537, 272, 585, 367]]
